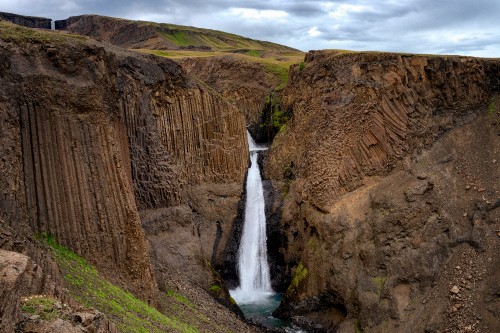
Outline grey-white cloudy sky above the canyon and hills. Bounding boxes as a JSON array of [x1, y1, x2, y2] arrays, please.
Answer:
[[0, 0, 500, 57]]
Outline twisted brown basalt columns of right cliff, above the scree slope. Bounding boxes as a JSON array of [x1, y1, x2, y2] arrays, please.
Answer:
[[268, 52, 489, 211]]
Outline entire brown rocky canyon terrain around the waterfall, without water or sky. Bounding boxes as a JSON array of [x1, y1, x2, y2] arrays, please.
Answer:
[[0, 11, 500, 333]]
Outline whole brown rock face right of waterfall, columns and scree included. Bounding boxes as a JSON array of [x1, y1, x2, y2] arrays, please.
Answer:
[[266, 51, 500, 332]]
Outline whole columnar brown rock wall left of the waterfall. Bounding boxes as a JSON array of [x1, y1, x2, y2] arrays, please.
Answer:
[[0, 23, 248, 322]]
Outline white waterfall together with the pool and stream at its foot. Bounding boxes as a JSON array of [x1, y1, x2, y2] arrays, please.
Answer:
[[229, 132, 303, 332]]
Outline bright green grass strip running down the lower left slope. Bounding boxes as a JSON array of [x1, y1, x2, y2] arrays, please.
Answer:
[[38, 234, 199, 333]]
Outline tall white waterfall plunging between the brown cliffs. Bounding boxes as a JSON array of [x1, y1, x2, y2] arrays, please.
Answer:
[[231, 133, 274, 304]]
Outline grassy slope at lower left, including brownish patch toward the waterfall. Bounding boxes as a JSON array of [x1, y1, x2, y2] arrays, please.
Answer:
[[39, 234, 231, 333]]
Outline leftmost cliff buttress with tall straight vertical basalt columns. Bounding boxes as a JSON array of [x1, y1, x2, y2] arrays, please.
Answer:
[[1, 34, 154, 297]]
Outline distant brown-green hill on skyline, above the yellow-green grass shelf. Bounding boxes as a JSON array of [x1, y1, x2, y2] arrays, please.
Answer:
[[56, 15, 298, 52]]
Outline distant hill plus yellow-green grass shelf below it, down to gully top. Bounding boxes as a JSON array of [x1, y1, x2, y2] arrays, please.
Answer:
[[62, 15, 304, 85]]
